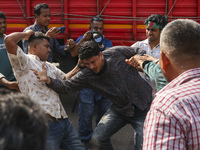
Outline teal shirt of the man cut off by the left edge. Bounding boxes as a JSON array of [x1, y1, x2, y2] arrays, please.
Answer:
[[0, 35, 15, 86]]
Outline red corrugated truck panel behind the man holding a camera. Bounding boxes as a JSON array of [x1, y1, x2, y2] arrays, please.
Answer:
[[69, 0, 133, 45]]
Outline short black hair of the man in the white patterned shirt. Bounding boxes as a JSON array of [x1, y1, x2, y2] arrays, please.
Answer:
[[28, 32, 50, 45]]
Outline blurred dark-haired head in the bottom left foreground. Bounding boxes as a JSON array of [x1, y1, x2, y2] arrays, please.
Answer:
[[0, 88, 48, 150]]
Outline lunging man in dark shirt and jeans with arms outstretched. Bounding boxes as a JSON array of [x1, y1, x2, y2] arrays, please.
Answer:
[[35, 41, 152, 150]]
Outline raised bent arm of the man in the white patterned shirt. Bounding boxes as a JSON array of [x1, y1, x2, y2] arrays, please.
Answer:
[[5, 30, 34, 55]]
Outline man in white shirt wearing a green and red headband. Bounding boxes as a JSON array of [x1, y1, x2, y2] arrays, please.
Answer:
[[131, 14, 168, 95]]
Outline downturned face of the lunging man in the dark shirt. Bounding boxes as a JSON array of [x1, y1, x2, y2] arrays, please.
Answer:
[[83, 52, 104, 73]]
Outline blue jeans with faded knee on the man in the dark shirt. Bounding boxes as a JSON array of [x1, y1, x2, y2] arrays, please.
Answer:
[[92, 107, 149, 150]]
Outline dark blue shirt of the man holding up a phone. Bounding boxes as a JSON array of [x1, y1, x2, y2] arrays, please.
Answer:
[[22, 22, 65, 62]]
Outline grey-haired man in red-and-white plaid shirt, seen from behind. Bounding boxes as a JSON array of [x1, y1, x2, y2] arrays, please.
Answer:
[[143, 19, 200, 150]]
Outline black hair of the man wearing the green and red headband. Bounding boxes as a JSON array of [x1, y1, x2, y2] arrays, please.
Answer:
[[144, 14, 168, 28]]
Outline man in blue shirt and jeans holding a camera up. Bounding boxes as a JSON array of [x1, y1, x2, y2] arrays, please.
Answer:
[[73, 17, 113, 148]]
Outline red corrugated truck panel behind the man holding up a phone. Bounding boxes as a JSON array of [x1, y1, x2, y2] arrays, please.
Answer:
[[0, 0, 64, 38]]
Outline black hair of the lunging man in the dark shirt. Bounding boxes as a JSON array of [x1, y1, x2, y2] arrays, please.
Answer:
[[78, 40, 100, 60]]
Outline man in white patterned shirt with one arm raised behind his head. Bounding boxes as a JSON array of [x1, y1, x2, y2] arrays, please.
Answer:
[[5, 30, 84, 150]]
